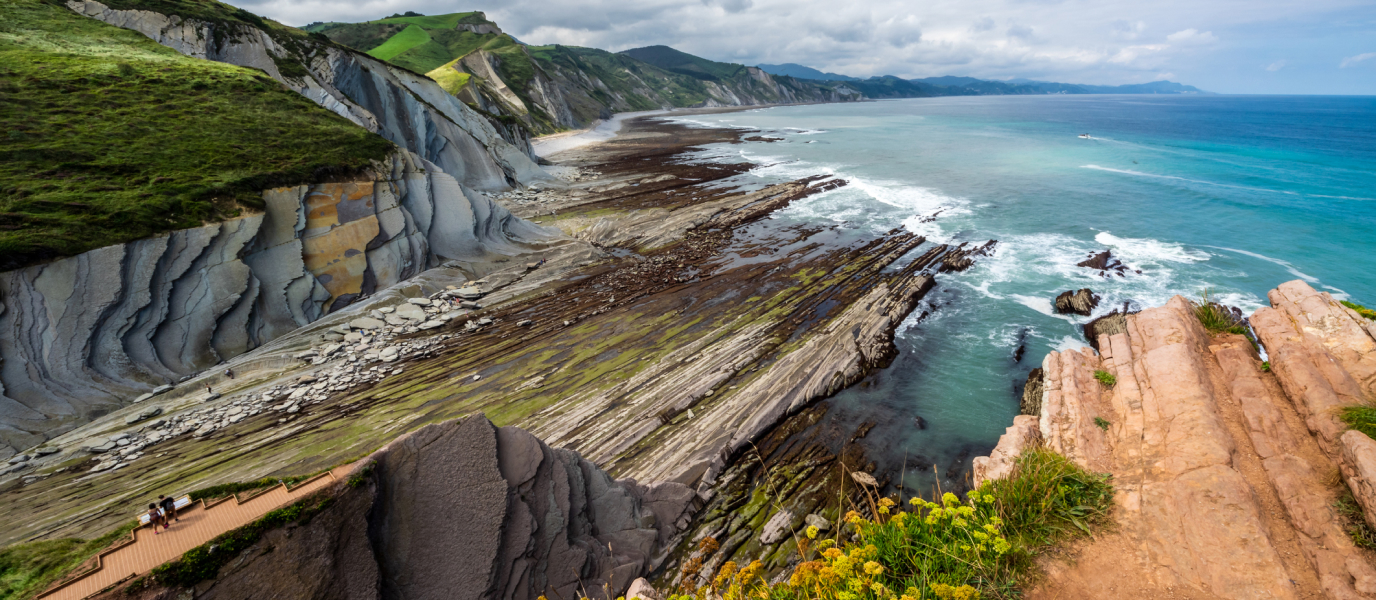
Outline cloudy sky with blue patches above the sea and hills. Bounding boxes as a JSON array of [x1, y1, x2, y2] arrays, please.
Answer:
[[230, 0, 1376, 95]]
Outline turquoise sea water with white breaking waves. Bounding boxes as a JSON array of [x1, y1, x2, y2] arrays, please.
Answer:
[[677, 96, 1376, 491]]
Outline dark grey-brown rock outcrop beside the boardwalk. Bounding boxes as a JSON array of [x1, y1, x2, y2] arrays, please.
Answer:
[[111, 417, 692, 600]]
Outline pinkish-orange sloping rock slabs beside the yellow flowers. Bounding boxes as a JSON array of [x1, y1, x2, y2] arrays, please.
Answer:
[[976, 281, 1376, 599]]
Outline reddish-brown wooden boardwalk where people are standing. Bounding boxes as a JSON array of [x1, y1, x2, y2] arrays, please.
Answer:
[[39, 465, 348, 600]]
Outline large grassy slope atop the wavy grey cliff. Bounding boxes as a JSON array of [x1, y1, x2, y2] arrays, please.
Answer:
[[0, 0, 392, 270]]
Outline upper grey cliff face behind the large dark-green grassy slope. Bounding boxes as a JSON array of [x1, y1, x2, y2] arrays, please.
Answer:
[[67, 0, 552, 190]]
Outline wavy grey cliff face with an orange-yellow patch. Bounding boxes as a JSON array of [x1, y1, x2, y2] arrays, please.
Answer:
[[0, 151, 553, 458]]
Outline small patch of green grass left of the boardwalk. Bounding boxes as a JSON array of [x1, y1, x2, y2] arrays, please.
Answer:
[[0, 522, 138, 600]]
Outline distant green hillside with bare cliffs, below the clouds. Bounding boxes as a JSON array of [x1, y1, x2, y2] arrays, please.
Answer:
[[316, 12, 860, 133]]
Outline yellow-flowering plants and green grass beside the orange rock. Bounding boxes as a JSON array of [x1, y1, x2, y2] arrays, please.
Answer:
[[670, 449, 1113, 600]]
